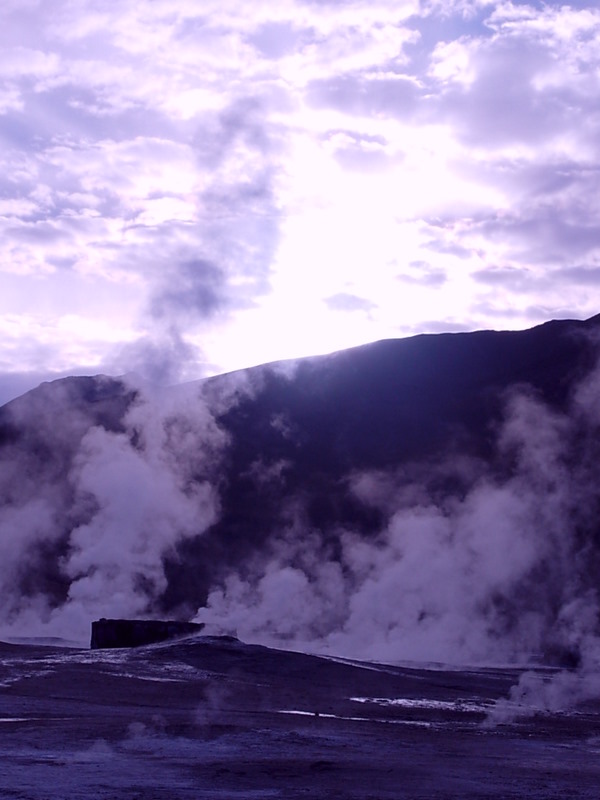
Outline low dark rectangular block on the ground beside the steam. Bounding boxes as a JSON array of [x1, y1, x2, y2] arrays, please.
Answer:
[[90, 617, 204, 650]]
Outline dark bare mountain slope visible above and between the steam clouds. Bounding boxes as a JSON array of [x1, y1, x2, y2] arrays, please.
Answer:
[[165, 315, 600, 605]]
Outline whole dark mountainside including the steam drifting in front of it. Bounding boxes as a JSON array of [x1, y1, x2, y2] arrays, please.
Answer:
[[0, 317, 600, 660]]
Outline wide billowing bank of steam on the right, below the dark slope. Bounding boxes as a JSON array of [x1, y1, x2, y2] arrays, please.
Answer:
[[197, 370, 600, 663]]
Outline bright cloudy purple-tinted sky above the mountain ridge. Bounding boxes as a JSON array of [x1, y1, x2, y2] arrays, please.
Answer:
[[0, 0, 600, 402]]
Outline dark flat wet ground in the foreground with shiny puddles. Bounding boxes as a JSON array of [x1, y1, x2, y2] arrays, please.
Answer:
[[0, 636, 600, 800]]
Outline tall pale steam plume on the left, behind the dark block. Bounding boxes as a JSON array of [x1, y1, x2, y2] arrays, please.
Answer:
[[0, 378, 226, 640]]
